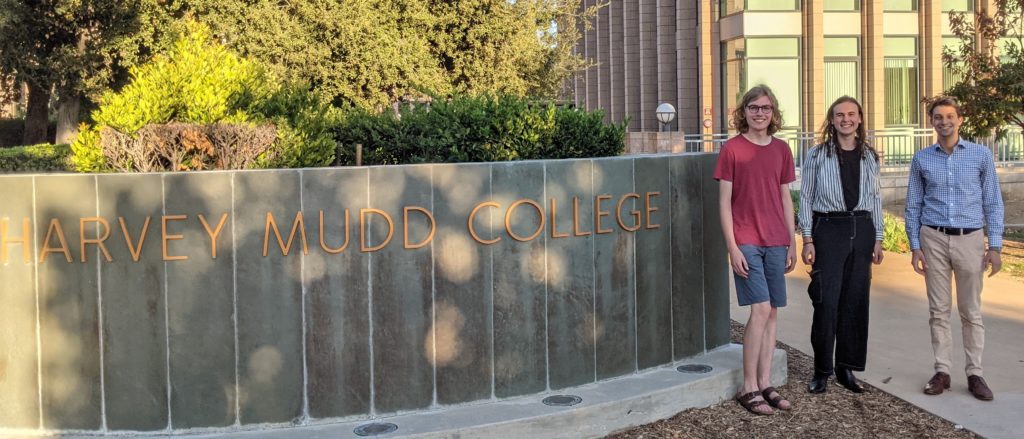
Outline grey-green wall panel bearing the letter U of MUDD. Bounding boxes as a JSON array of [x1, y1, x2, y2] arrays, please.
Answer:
[[302, 169, 371, 419]]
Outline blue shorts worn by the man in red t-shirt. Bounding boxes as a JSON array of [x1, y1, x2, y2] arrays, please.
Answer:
[[733, 245, 788, 308]]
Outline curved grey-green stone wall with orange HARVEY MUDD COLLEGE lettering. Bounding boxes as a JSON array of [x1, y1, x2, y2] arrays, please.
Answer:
[[0, 153, 729, 432]]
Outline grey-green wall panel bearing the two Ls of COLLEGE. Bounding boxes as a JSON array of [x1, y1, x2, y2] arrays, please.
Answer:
[[545, 160, 595, 389]]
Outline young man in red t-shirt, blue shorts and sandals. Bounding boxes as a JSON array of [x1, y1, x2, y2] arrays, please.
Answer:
[[715, 85, 797, 414]]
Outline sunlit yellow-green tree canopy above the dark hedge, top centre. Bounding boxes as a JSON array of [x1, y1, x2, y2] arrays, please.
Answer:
[[176, 0, 594, 111]]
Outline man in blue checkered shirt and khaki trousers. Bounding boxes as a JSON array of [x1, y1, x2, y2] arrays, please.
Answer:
[[906, 97, 1002, 401]]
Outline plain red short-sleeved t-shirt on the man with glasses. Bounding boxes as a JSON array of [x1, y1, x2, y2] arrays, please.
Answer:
[[715, 135, 797, 247]]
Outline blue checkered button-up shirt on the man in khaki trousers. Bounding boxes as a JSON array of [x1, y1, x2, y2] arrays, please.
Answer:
[[906, 139, 1002, 250]]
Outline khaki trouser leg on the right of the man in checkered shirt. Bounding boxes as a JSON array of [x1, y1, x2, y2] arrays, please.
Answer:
[[949, 230, 985, 377]]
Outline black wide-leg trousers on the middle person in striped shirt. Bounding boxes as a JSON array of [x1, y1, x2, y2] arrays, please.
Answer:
[[807, 213, 874, 374]]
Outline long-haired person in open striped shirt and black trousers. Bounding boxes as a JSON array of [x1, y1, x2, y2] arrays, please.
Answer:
[[799, 96, 883, 393]]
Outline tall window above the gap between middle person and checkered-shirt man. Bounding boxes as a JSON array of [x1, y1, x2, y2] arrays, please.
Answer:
[[885, 37, 921, 126]]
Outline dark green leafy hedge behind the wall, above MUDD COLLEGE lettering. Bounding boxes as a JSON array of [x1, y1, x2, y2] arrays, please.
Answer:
[[335, 95, 626, 165]]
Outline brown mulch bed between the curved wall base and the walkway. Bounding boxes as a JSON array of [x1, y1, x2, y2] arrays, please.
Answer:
[[607, 321, 980, 439]]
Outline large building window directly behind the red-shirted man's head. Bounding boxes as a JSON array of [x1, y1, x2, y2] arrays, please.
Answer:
[[719, 37, 801, 127]]
